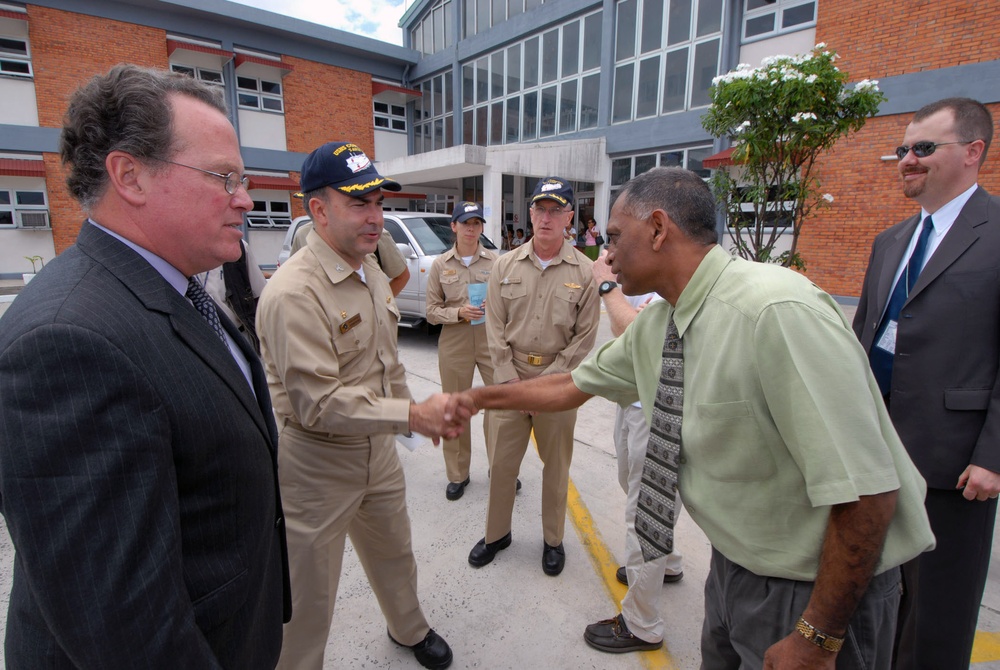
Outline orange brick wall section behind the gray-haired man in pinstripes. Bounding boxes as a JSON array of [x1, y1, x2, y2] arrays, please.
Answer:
[[27, 5, 168, 253]]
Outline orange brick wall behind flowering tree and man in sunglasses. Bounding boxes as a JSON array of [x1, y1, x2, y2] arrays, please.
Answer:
[[799, 0, 1000, 296]]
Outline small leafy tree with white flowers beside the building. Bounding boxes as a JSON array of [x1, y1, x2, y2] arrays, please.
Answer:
[[702, 43, 885, 270]]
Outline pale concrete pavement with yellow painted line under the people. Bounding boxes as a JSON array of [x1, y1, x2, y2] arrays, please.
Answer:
[[0, 290, 1000, 670]]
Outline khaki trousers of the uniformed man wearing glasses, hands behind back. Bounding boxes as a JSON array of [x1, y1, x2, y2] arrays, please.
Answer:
[[486, 360, 576, 547]]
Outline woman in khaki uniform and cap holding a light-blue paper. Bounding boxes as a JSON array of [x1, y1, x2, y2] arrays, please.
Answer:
[[427, 202, 497, 500]]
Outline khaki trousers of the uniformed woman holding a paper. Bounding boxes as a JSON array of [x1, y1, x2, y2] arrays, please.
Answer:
[[438, 321, 493, 484]]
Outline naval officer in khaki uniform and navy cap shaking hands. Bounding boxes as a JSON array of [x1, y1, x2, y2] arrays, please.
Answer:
[[257, 142, 458, 670]]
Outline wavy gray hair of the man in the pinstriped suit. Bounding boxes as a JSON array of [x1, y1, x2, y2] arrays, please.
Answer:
[[59, 64, 226, 210]]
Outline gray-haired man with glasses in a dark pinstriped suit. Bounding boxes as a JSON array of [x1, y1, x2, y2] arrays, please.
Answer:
[[0, 65, 288, 669]]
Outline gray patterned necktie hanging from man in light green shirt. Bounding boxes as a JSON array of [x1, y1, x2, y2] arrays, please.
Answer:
[[635, 316, 684, 561]]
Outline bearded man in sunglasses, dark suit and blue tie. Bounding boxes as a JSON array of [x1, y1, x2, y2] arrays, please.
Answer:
[[854, 98, 1000, 669]]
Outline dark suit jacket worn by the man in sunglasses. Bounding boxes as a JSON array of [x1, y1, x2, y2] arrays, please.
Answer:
[[854, 188, 1000, 489]]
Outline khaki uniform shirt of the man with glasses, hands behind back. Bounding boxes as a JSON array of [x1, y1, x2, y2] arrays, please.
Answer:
[[486, 240, 601, 384]]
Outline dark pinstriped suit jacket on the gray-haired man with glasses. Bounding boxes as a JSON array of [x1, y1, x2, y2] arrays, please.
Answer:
[[0, 224, 287, 669]]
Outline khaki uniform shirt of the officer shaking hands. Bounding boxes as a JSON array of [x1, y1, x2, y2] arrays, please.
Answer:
[[257, 231, 410, 444]]
